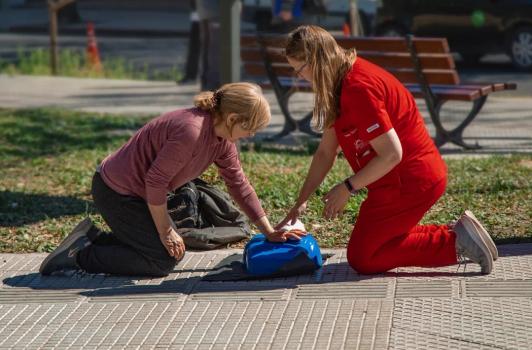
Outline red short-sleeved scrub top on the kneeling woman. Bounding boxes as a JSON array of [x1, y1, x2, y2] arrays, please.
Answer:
[[333, 57, 447, 192]]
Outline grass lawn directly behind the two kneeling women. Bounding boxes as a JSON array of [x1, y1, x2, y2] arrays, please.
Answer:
[[0, 109, 532, 252]]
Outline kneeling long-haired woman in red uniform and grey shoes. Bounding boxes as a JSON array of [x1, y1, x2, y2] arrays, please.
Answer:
[[278, 26, 497, 274]]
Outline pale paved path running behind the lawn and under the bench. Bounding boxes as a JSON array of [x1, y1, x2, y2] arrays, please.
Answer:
[[0, 75, 532, 154]]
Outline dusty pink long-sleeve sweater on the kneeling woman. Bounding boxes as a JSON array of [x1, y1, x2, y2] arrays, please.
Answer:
[[100, 108, 265, 221]]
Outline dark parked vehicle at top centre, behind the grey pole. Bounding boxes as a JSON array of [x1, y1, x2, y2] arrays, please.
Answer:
[[242, 0, 378, 35]]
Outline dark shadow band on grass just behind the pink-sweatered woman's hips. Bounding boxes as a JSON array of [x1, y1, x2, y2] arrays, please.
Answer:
[[0, 191, 93, 227]]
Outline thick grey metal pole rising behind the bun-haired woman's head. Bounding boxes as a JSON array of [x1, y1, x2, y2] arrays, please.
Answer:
[[220, 0, 240, 84]]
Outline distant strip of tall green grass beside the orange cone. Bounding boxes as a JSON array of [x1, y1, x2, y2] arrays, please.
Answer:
[[0, 49, 182, 81]]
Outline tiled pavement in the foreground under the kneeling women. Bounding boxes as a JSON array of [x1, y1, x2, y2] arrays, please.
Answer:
[[0, 244, 532, 350]]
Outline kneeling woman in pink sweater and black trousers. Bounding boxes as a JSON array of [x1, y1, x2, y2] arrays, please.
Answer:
[[40, 83, 298, 276]]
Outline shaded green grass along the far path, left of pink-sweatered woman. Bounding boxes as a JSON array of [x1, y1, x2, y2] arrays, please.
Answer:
[[0, 109, 146, 160]]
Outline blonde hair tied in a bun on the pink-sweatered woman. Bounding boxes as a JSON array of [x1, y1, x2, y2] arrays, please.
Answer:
[[194, 83, 271, 133]]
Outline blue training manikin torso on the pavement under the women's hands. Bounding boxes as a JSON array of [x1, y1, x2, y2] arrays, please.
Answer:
[[244, 233, 323, 276]]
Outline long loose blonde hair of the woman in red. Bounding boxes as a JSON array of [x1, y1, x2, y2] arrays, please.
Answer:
[[285, 25, 357, 130]]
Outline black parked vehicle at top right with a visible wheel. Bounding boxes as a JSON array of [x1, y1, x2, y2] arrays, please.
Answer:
[[375, 0, 532, 70]]
